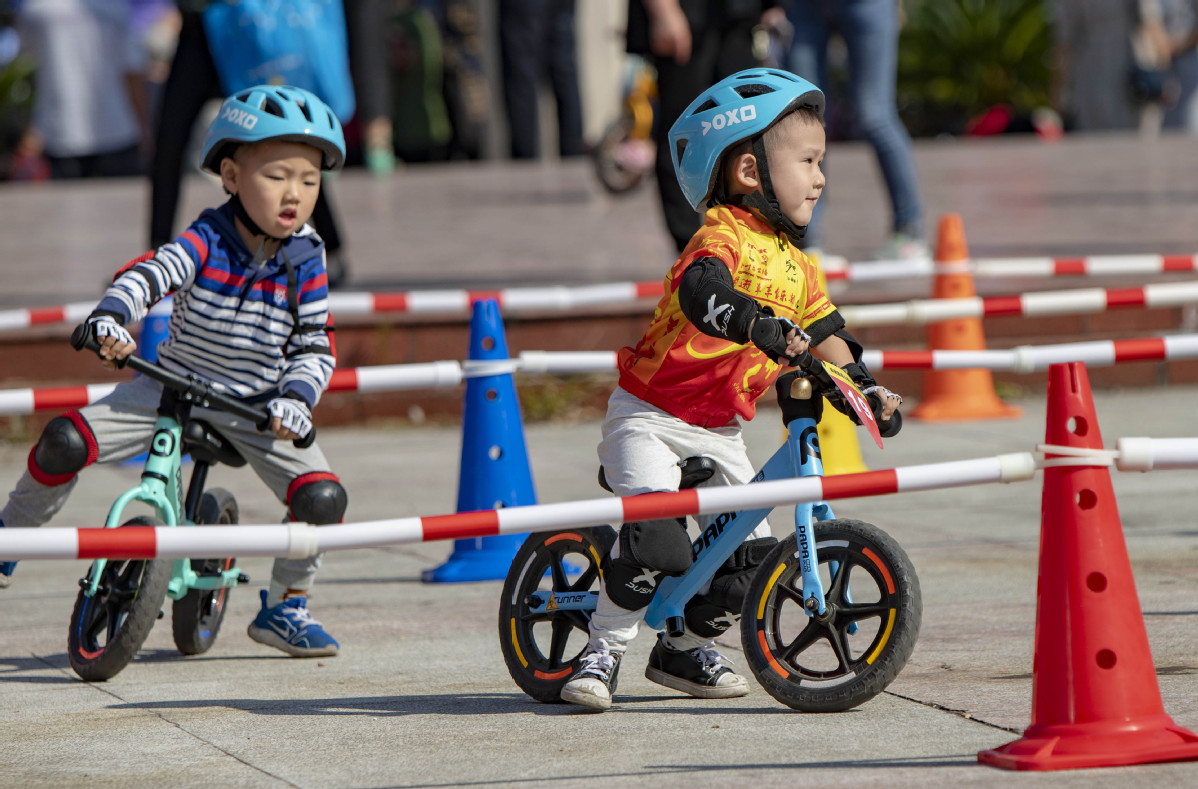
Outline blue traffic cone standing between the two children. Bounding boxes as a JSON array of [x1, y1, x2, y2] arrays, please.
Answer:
[[422, 299, 537, 583]]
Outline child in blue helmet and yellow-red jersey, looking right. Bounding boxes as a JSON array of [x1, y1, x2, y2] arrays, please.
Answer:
[[562, 68, 902, 710]]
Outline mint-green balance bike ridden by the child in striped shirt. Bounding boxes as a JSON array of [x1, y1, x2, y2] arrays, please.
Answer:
[[67, 324, 315, 681]]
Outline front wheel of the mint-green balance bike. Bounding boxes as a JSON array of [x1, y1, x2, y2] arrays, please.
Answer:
[[67, 516, 171, 682]]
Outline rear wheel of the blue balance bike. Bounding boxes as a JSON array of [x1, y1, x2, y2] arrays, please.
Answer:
[[500, 526, 616, 703]]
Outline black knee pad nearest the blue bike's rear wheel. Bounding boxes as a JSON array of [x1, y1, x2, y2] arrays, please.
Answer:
[[604, 518, 691, 611]]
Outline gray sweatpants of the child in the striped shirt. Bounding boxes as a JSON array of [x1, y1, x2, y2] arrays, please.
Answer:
[[0, 376, 329, 590]]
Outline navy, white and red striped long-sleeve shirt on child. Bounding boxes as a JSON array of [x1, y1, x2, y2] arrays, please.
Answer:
[[97, 204, 335, 406]]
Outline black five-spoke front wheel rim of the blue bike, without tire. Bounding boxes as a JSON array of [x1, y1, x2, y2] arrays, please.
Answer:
[[746, 535, 901, 686]]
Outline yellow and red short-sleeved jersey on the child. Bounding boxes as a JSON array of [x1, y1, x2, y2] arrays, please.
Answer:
[[617, 205, 836, 427]]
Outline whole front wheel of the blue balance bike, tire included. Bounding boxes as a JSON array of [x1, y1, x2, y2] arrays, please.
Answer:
[[740, 520, 922, 712]]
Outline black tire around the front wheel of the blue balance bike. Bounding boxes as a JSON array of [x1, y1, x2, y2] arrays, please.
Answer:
[[740, 520, 922, 712]]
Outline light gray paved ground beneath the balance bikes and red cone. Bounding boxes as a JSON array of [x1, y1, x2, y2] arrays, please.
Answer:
[[0, 380, 1198, 789]]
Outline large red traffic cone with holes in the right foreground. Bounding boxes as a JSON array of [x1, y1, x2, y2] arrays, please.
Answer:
[[978, 362, 1198, 770]]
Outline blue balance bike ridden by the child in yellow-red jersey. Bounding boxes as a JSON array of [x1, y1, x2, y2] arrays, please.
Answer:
[[498, 354, 922, 712]]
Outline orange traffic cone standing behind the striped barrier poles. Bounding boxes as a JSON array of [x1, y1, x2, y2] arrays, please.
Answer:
[[910, 213, 1022, 421]]
